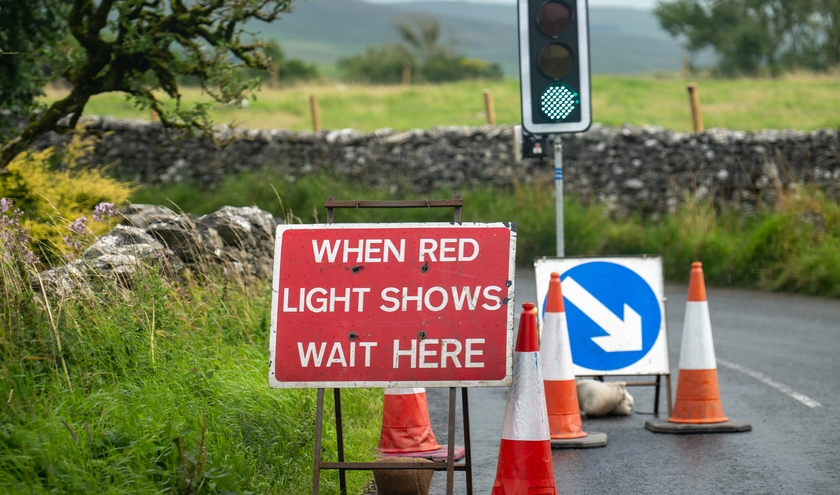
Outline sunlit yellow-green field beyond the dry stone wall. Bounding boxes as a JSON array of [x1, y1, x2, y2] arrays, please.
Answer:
[[42, 73, 840, 132]]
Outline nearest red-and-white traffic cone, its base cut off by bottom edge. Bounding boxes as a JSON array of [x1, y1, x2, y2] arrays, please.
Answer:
[[491, 303, 557, 495]]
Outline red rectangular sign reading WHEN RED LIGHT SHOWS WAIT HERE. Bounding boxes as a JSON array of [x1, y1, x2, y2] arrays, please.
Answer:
[[269, 223, 516, 388]]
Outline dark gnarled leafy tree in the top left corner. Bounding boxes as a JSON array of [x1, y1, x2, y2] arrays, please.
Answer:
[[0, 0, 292, 173]]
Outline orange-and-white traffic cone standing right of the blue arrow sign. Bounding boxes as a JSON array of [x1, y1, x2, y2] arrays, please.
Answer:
[[645, 261, 752, 433]]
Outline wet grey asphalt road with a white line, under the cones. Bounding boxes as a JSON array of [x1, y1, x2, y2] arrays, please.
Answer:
[[427, 270, 840, 495]]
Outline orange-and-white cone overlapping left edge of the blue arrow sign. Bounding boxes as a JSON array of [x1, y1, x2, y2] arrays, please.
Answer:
[[540, 272, 607, 449]]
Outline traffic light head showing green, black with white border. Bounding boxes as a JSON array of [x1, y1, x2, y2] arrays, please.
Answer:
[[517, 0, 592, 134]]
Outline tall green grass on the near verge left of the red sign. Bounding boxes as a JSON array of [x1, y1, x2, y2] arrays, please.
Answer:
[[0, 249, 381, 494]]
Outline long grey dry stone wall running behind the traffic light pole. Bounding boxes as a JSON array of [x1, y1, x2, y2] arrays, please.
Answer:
[[37, 117, 840, 217]]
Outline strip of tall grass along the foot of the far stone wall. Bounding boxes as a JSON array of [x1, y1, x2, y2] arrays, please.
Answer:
[[133, 172, 840, 297]]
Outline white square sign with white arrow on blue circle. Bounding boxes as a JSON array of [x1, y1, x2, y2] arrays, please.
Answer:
[[534, 256, 671, 376]]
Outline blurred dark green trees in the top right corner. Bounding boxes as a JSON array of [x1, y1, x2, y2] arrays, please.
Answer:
[[654, 0, 840, 75]]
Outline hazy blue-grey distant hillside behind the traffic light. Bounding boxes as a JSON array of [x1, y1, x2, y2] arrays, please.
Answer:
[[249, 0, 709, 75]]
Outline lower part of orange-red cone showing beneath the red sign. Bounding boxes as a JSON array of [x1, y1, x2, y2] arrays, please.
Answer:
[[377, 388, 465, 461]]
